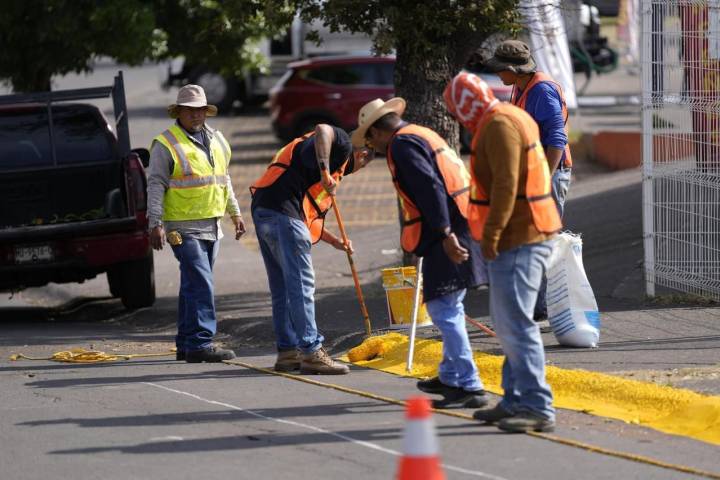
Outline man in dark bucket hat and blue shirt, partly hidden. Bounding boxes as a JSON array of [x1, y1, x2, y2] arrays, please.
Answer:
[[485, 40, 572, 321]]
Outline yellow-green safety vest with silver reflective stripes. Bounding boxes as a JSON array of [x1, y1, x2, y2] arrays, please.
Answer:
[[153, 125, 230, 221]]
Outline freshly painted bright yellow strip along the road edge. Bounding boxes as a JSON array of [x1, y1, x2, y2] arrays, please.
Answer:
[[342, 333, 720, 445]]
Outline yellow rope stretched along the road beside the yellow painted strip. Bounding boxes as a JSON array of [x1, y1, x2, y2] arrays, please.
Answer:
[[223, 356, 720, 480]]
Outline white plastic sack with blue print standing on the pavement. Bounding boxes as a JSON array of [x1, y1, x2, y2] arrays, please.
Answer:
[[545, 232, 600, 348]]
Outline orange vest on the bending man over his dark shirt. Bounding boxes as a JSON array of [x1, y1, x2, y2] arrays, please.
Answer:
[[250, 132, 347, 243]]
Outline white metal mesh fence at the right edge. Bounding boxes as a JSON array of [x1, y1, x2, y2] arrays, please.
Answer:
[[640, 0, 720, 301]]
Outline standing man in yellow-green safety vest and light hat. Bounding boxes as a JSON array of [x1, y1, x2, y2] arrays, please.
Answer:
[[148, 85, 245, 363]]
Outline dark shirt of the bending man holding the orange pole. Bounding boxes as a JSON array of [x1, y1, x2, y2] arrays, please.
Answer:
[[250, 127, 354, 220]]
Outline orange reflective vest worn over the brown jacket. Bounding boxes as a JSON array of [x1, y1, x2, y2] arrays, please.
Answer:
[[468, 103, 562, 241]]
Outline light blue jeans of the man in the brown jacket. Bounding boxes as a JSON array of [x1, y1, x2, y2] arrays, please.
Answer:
[[488, 241, 555, 420]]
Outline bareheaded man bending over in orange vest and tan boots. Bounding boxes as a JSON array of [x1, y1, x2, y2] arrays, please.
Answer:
[[250, 124, 372, 375]]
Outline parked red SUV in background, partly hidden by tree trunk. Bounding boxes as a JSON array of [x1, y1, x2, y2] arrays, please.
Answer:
[[270, 55, 511, 148]]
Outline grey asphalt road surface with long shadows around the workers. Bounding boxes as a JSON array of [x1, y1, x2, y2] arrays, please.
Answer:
[[0, 65, 718, 480]]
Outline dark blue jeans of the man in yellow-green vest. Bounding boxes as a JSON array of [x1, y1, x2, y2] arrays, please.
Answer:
[[172, 236, 220, 351]]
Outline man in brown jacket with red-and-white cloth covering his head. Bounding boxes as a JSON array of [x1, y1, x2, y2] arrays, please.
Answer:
[[444, 72, 561, 432]]
